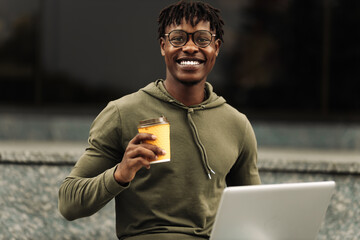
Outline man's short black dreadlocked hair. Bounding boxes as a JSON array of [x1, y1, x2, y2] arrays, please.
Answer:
[[158, 0, 224, 42]]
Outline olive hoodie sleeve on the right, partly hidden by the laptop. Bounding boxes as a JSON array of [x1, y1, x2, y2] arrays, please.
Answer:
[[226, 118, 261, 186]]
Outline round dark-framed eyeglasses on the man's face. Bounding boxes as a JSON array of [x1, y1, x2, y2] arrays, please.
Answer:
[[164, 30, 216, 48]]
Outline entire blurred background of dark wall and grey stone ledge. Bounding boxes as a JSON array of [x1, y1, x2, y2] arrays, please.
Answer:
[[0, 0, 360, 240]]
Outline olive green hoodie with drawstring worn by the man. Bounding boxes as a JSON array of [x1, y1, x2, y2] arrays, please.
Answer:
[[59, 80, 260, 240]]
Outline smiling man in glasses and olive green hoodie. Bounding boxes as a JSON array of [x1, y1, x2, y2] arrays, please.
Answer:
[[59, 1, 260, 240]]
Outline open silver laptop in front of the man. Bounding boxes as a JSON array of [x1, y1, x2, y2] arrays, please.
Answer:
[[210, 181, 335, 240]]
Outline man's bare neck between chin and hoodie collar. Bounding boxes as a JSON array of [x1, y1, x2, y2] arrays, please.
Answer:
[[164, 80, 205, 106]]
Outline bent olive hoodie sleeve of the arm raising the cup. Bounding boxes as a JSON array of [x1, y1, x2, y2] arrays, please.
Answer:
[[58, 103, 126, 220]]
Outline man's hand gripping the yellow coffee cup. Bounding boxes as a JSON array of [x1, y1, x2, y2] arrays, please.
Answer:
[[114, 133, 165, 185]]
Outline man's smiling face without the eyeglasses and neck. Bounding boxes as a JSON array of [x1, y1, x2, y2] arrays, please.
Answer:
[[160, 20, 221, 84]]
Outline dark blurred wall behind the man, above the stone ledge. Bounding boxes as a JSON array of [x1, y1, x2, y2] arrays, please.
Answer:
[[0, 0, 360, 121]]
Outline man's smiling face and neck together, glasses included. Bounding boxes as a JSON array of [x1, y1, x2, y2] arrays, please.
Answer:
[[160, 19, 221, 106]]
